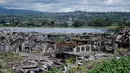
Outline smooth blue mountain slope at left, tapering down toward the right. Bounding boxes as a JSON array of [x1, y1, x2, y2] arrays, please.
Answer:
[[0, 6, 42, 15]]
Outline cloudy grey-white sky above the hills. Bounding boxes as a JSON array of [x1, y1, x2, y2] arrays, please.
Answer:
[[0, 0, 130, 12]]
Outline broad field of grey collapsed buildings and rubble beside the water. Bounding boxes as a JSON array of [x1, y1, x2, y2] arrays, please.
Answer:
[[0, 31, 119, 73]]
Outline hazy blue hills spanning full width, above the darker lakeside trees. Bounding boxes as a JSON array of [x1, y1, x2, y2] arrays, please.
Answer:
[[0, 6, 130, 21]]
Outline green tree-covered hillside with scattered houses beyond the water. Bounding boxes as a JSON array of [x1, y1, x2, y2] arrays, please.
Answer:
[[0, 11, 130, 27]]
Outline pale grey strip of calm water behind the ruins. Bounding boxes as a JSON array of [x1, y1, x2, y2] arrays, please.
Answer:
[[0, 27, 106, 33]]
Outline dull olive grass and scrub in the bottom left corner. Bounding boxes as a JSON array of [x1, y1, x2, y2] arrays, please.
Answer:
[[0, 52, 21, 73]]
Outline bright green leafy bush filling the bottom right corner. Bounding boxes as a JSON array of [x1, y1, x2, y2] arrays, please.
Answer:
[[87, 57, 130, 73]]
